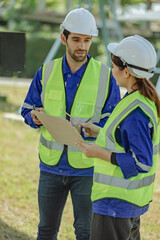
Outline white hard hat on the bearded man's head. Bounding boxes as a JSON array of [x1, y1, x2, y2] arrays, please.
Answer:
[[60, 8, 98, 36]]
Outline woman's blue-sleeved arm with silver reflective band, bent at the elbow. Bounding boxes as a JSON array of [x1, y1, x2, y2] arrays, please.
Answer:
[[115, 108, 153, 178]]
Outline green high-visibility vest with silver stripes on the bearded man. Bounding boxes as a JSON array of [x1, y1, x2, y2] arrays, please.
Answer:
[[39, 58, 110, 169]]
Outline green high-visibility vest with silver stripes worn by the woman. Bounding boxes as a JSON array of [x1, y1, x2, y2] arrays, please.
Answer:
[[91, 91, 160, 206]]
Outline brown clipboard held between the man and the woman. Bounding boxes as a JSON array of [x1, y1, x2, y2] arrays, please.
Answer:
[[33, 111, 84, 148]]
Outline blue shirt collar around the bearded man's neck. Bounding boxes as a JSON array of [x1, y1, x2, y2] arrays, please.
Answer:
[[62, 54, 91, 77]]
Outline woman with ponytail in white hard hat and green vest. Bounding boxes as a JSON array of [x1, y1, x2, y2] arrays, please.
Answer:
[[77, 35, 160, 240]]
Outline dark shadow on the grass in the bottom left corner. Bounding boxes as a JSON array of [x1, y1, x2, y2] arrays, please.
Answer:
[[0, 219, 34, 240]]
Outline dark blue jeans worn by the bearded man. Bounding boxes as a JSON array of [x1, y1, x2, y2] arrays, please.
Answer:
[[37, 171, 93, 240]]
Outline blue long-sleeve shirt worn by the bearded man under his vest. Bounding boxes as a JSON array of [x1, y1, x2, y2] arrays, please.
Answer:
[[21, 55, 120, 176]]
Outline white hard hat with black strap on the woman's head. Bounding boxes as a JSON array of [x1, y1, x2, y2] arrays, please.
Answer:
[[107, 35, 157, 79]]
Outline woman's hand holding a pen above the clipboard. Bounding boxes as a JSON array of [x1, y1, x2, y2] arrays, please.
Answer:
[[82, 122, 101, 138]]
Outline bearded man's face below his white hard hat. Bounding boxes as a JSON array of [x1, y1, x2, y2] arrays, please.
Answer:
[[63, 33, 92, 62]]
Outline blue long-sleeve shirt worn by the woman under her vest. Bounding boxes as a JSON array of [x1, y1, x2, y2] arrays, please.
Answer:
[[93, 92, 153, 218]]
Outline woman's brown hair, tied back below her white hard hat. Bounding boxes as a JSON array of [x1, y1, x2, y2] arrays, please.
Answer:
[[111, 54, 160, 118]]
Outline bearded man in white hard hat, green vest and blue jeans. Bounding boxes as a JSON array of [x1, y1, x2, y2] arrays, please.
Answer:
[[22, 8, 120, 240]]
